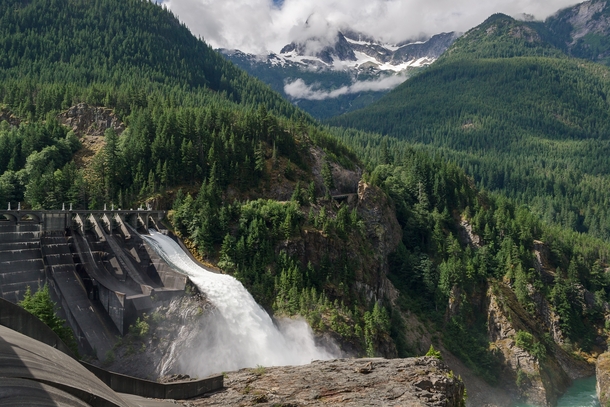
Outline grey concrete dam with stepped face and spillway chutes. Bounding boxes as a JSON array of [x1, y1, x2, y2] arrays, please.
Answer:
[[0, 209, 187, 360]]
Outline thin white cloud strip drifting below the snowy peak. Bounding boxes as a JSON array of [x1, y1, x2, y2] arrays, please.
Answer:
[[284, 75, 406, 100]]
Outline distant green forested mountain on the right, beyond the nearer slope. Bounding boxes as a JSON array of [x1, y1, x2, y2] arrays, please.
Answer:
[[330, 11, 610, 239]]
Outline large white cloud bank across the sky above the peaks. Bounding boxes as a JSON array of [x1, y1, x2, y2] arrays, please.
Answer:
[[163, 0, 578, 54]]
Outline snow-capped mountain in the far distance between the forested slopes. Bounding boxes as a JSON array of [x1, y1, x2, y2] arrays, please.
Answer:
[[220, 30, 458, 118]]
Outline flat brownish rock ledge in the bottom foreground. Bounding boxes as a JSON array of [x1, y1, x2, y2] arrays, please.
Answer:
[[187, 357, 464, 407]]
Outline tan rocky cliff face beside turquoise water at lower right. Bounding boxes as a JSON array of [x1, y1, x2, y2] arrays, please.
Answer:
[[448, 219, 594, 406]]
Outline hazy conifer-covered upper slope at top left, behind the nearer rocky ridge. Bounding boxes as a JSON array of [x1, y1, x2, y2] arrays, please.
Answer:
[[0, 0, 297, 118]]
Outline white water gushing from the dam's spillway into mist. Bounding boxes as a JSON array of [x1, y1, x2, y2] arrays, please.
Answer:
[[142, 230, 335, 376]]
